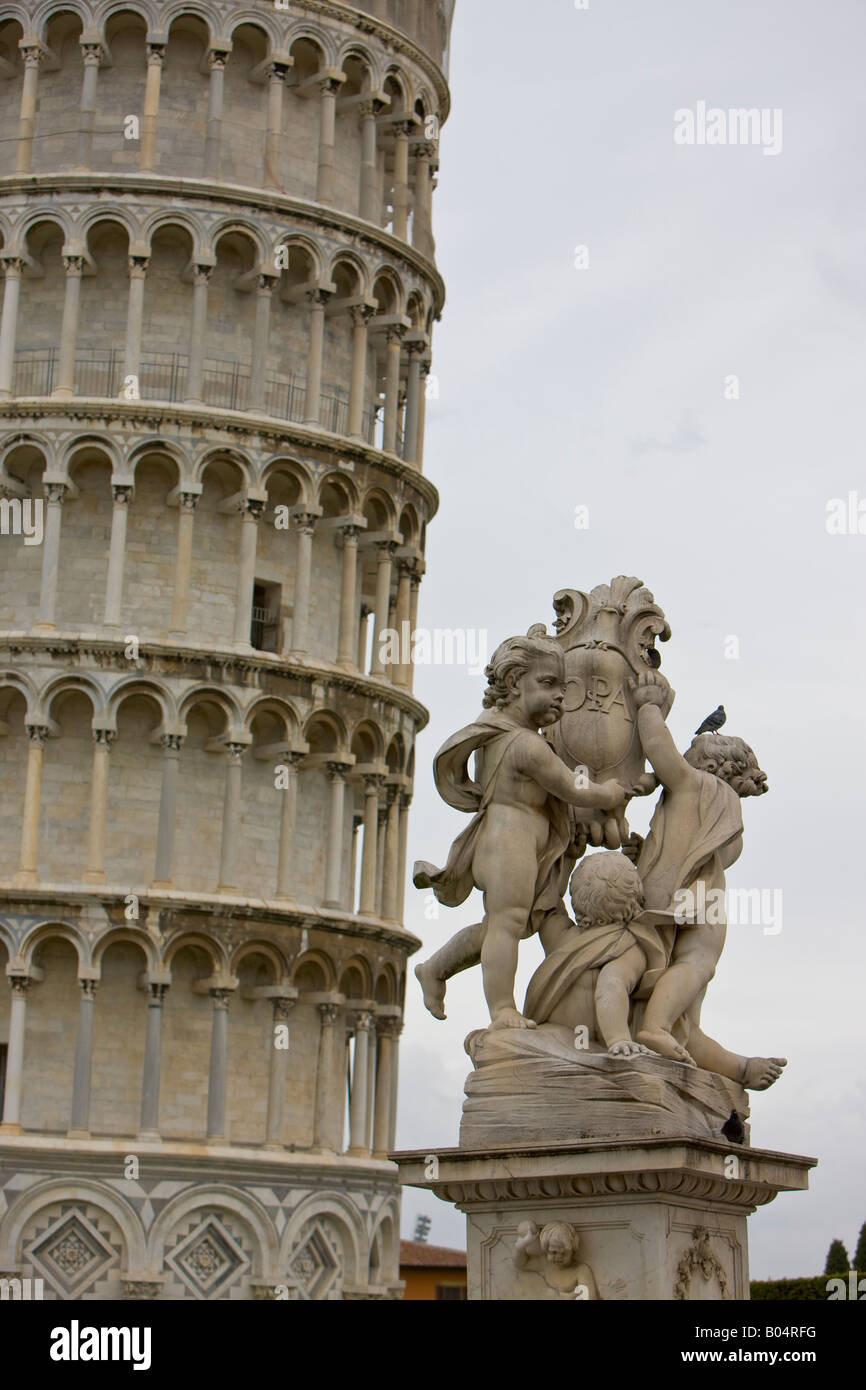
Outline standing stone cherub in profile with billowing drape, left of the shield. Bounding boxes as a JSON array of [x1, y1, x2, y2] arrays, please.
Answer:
[[413, 637, 626, 1029]]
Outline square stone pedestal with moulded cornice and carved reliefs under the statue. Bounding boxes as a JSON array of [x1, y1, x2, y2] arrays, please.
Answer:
[[393, 1137, 816, 1301]]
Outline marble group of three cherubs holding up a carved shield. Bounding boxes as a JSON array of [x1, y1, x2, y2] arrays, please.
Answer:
[[414, 577, 785, 1112]]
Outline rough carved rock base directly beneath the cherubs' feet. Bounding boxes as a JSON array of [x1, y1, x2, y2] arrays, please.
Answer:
[[460, 1023, 749, 1148]]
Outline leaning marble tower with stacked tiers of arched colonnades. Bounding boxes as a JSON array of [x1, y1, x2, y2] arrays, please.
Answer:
[[0, 0, 453, 1300]]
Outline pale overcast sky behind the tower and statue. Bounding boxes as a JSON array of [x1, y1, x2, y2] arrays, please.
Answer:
[[398, 0, 866, 1277]]
